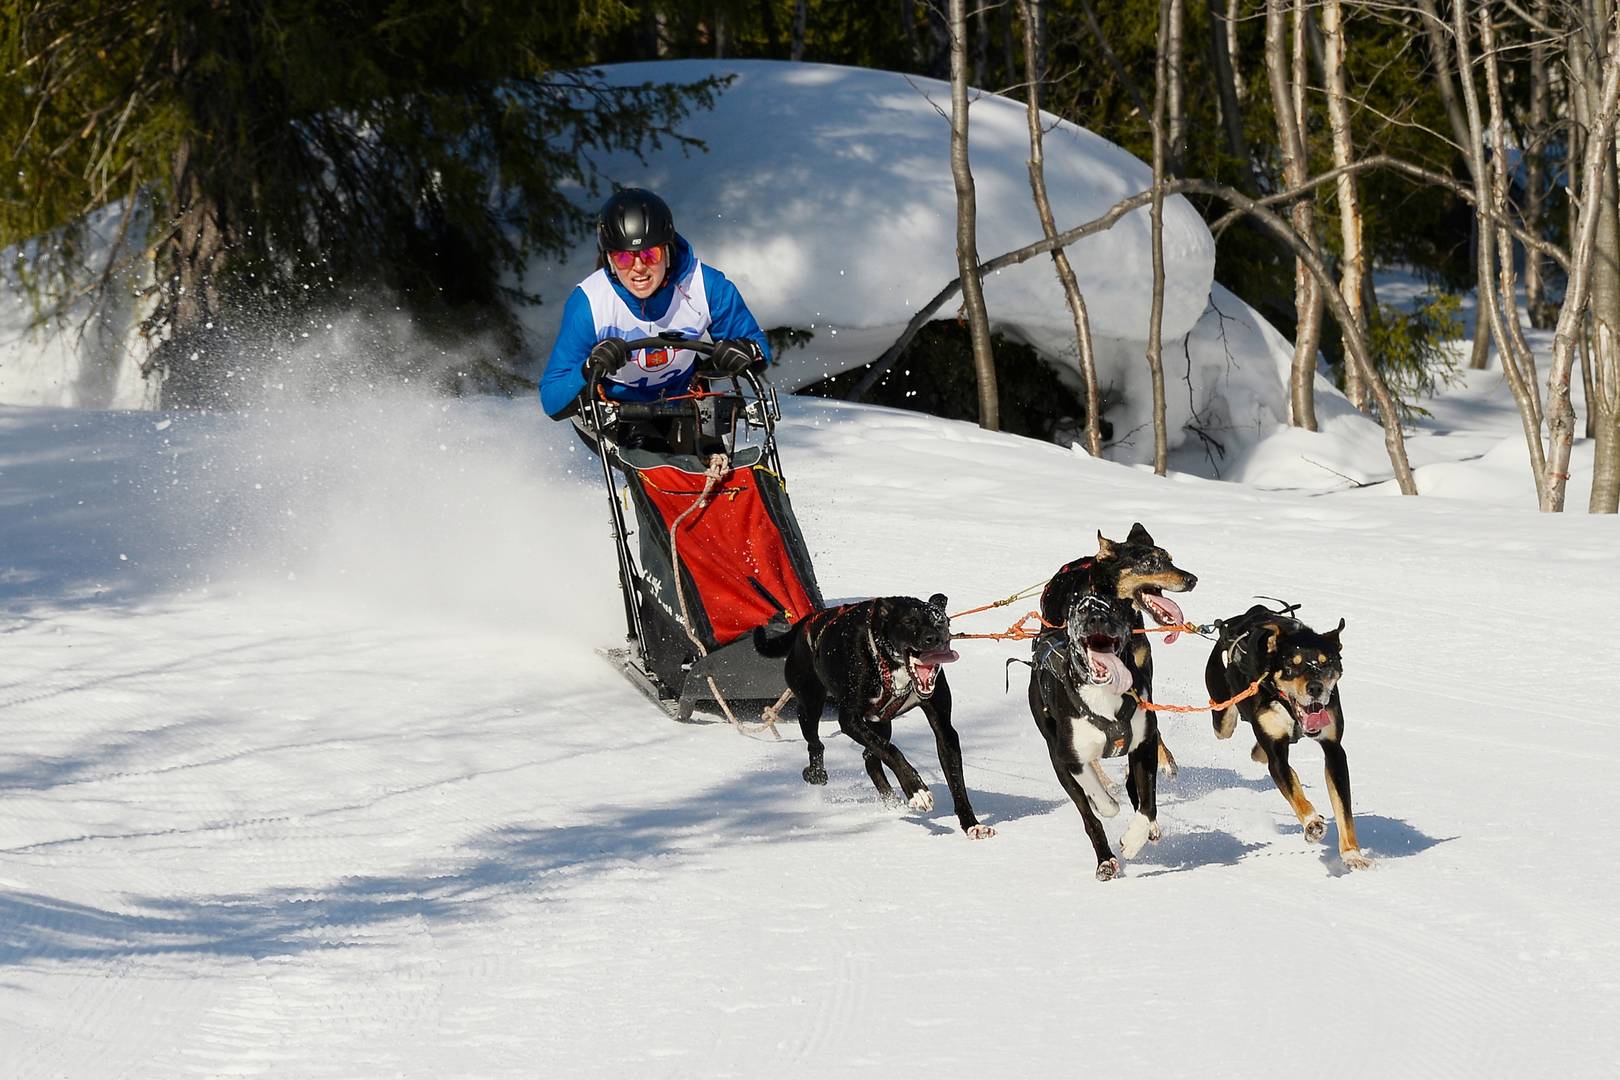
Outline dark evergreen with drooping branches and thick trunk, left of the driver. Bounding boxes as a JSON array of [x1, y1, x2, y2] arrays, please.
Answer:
[[0, 0, 716, 405]]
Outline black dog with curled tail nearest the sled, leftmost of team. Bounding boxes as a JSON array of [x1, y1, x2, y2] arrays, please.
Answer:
[[753, 593, 995, 840]]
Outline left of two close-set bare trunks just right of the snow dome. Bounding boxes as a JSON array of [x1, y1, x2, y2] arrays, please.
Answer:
[[1265, 0, 1315, 431]]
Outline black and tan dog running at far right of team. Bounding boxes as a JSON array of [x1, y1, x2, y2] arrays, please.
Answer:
[[1204, 604, 1372, 870]]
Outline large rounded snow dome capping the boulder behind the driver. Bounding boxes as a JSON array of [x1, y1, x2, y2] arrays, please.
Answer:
[[530, 60, 1215, 351]]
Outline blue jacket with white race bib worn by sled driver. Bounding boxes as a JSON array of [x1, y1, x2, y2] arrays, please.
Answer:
[[539, 235, 771, 418]]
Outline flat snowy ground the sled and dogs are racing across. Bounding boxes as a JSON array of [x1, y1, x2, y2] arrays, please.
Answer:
[[0, 400, 1620, 1078]]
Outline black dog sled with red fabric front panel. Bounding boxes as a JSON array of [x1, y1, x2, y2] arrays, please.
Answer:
[[575, 335, 821, 721]]
